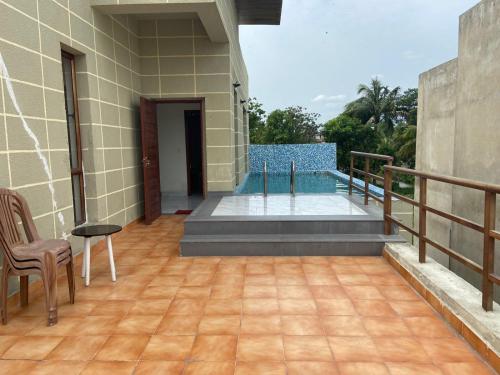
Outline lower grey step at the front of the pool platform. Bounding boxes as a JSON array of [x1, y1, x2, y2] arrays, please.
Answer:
[[181, 234, 406, 256]]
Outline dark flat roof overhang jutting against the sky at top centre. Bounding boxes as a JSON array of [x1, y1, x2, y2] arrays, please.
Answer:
[[236, 0, 283, 25]]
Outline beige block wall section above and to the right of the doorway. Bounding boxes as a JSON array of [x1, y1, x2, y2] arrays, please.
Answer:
[[138, 14, 248, 192]]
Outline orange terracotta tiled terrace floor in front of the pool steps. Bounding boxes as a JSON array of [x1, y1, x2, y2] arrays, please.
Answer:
[[0, 216, 491, 375]]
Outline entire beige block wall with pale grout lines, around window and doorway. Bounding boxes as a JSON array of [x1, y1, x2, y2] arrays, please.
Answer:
[[0, 0, 248, 294]]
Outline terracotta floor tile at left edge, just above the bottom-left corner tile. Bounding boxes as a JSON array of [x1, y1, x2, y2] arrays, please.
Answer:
[[2, 336, 63, 360]]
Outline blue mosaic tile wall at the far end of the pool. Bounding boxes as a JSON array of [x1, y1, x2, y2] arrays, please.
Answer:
[[248, 143, 337, 172]]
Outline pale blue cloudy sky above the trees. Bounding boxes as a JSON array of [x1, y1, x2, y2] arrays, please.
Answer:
[[240, 0, 479, 122]]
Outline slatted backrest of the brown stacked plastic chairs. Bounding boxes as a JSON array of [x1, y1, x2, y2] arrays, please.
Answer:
[[0, 188, 40, 268]]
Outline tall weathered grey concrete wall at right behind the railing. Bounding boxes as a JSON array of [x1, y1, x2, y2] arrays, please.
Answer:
[[417, 0, 500, 300]]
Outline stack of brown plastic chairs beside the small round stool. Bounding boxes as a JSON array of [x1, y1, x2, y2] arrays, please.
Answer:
[[0, 188, 75, 326]]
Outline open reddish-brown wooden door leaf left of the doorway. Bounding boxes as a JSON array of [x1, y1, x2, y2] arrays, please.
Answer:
[[141, 98, 161, 224]]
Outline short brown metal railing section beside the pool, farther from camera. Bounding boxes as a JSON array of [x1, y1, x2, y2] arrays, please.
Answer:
[[349, 151, 394, 205]]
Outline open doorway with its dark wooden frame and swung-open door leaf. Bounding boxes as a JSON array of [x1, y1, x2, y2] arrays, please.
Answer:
[[141, 99, 207, 223]]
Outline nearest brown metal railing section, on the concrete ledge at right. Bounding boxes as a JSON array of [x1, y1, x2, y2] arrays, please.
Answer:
[[384, 165, 500, 311]]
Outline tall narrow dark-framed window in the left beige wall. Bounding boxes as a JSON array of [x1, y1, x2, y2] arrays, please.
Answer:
[[62, 52, 85, 225]]
